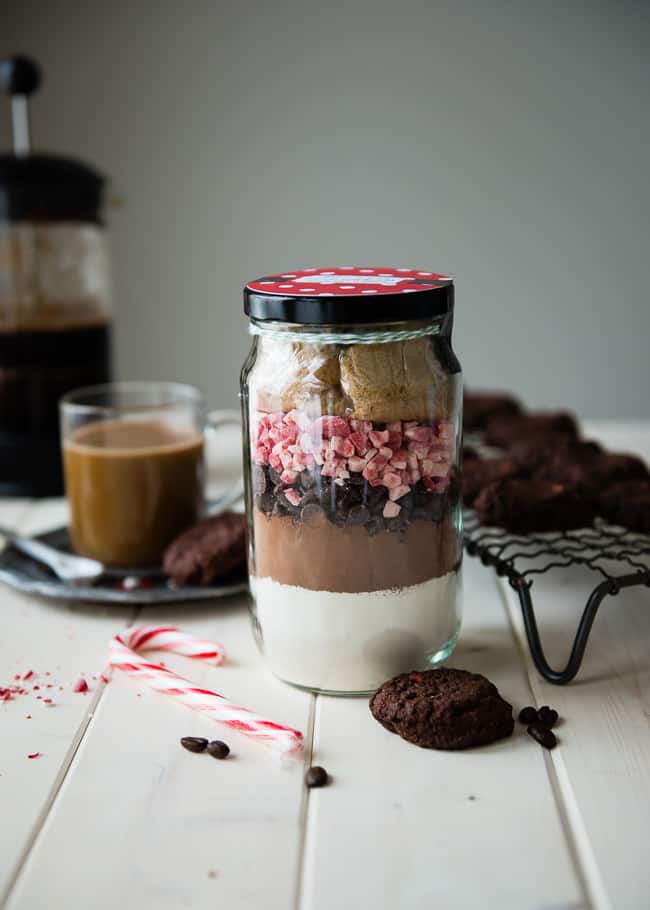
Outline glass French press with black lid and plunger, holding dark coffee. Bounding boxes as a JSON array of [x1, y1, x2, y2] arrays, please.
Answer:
[[0, 57, 111, 496]]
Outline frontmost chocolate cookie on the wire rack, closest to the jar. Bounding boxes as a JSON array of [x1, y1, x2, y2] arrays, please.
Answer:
[[474, 478, 596, 534]]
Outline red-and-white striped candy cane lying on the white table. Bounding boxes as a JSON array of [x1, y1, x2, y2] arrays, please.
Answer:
[[109, 626, 303, 753]]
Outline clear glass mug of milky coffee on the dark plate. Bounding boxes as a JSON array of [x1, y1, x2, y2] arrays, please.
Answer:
[[60, 382, 239, 567]]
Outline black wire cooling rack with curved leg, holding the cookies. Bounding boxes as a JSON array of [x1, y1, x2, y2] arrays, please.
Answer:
[[465, 510, 650, 685]]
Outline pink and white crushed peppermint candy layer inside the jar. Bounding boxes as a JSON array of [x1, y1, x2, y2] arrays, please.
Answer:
[[251, 410, 455, 518]]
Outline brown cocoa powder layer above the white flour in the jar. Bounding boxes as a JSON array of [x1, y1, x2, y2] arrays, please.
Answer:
[[251, 508, 461, 594]]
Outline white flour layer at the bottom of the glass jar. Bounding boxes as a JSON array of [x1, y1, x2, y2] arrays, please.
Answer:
[[251, 572, 460, 692]]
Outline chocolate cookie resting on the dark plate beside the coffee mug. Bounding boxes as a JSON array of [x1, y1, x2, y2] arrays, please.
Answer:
[[163, 512, 246, 586]]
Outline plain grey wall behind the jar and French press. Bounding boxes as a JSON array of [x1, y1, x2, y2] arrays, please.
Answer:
[[0, 0, 650, 417]]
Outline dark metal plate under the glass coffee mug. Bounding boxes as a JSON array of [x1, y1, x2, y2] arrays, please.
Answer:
[[0, 528, 248, 606]]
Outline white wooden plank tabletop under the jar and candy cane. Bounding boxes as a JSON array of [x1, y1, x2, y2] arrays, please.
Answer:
[[0, 424, 650, 910]]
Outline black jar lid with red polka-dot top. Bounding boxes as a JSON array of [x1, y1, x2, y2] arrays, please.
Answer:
[[244, 266, 453, 325]]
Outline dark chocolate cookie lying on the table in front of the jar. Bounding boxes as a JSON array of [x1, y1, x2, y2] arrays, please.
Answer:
[[370, 667, 514, 749]]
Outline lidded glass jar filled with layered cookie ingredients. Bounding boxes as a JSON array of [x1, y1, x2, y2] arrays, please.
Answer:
[[241, 268, 462, 695]]
